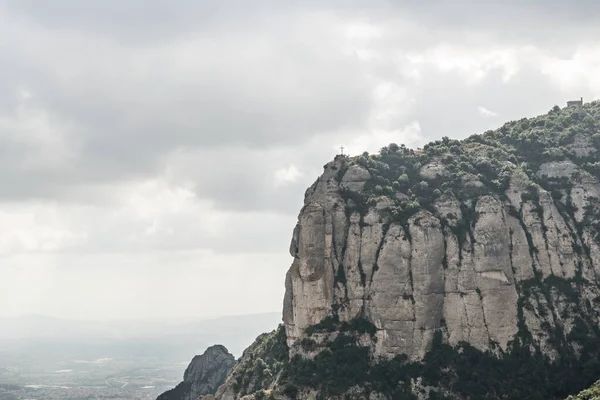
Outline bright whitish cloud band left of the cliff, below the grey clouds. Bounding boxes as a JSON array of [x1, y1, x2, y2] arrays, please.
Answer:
[[0, 179, 302, 256]]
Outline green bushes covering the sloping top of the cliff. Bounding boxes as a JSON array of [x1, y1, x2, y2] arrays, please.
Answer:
[[338, 102, 600, 232]]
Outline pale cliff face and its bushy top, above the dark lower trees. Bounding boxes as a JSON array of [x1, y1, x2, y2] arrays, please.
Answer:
[[284, 104, 600, 360]]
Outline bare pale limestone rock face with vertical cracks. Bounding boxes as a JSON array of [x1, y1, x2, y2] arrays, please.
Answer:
[[283, 157, 600, 361]]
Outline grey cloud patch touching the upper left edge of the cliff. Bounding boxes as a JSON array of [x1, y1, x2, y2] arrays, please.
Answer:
[[163, 142, 324, 215]]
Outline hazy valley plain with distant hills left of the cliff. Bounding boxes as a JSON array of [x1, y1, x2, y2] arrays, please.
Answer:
[[0, 313, 281, 400]]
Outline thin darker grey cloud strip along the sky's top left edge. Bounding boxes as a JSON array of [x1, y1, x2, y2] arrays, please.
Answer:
[[0, 0, 385, 44]]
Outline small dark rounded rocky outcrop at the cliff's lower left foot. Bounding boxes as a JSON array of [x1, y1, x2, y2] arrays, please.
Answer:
[[157, 345, 235, 400]]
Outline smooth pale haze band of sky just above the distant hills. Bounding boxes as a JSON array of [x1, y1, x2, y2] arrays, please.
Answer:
[[0, 251, 289, 320]]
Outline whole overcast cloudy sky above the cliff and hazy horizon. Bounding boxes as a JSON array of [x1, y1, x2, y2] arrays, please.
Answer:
[[0, 0, 600, 319]]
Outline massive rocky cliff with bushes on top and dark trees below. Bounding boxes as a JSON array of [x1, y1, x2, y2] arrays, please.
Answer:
[[209, 102, 600, 400]]
